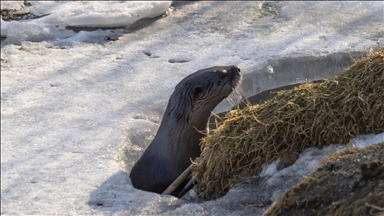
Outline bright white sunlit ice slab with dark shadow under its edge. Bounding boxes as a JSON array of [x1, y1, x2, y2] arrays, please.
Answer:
[[31, 1, 171, 27]]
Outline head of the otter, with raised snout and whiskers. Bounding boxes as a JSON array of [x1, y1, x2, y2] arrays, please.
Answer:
[[167, 66, 241, 126]]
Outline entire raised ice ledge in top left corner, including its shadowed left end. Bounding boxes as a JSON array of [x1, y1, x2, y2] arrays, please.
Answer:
[[1, 1, 171, 43]]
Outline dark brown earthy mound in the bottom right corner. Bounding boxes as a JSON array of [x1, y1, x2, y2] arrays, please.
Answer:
[[263, 143, 384, 216]]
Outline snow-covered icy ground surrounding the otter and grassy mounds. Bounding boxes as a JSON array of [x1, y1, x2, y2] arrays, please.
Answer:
[[1, 1, 384, 215]]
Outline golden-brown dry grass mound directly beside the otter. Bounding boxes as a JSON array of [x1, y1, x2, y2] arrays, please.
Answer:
[[193, 48, 384, 199]]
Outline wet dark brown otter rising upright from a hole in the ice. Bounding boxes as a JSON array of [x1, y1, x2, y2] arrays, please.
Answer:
[[130, 66, 241, 195]]
